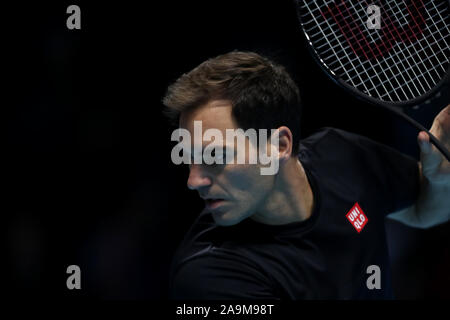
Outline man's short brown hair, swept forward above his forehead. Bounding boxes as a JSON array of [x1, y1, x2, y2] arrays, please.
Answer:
[[163, 51, 301, 155]]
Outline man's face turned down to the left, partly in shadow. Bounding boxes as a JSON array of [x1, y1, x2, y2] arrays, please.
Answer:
[[180, 100, 275, 226]]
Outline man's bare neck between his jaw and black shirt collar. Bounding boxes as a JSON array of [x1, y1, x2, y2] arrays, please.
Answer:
[[251, 157, 314, 225]]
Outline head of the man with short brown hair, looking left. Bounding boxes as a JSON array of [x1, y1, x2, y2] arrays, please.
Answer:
[[163, 51, 301, 225]]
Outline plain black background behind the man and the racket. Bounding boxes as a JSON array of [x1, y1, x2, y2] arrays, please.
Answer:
[[2, 1, 450, 299]]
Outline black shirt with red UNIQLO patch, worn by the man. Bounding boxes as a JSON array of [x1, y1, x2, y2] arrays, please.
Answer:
[[171, 128, 419, 299]]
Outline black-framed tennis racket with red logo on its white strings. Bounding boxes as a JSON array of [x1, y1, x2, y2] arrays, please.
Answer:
[[295, 0, 450, 161]]
